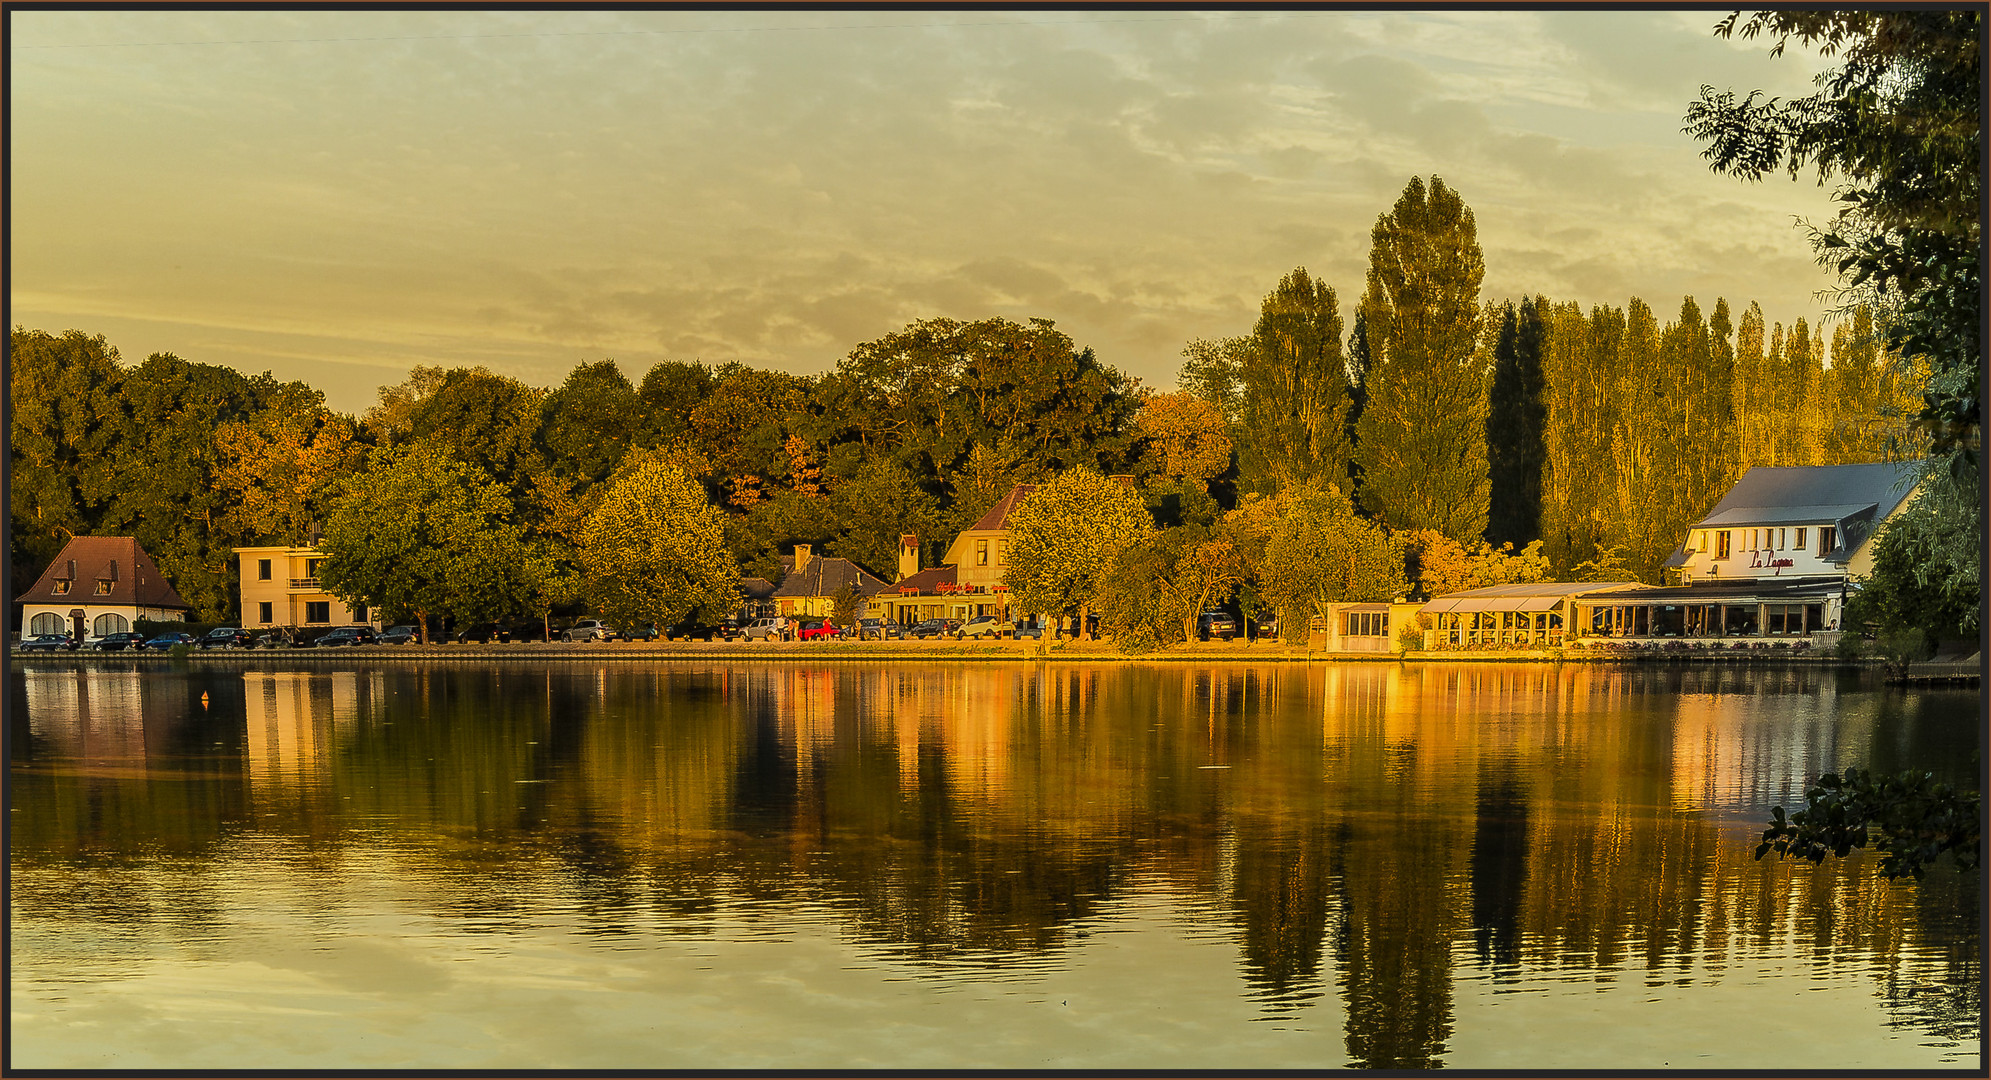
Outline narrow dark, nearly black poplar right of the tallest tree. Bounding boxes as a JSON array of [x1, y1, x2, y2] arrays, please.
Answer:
[[1485, 297, 1549, 546]]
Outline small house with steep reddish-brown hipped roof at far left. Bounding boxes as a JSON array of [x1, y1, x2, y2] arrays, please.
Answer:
[[18, 536, 187, 640]]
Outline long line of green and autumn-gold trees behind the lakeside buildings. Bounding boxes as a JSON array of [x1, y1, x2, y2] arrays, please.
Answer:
[[12, 177, 1917, 644]]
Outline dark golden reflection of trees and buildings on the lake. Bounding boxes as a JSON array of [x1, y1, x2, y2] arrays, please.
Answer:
[[10, 664, 1981, 1068]]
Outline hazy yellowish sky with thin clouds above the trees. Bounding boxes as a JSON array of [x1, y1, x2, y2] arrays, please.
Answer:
[[8, 10, 1834, 412]]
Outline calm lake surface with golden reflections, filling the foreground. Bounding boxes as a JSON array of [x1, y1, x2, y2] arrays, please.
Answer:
[[8, 662, 1983, 1070]]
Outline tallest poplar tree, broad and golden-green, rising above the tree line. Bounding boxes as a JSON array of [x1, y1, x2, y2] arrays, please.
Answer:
[[1356, 177, 1487, 542]]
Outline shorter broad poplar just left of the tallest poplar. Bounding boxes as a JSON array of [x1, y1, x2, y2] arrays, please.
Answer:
[[1236, 267, 1348, 494]]
